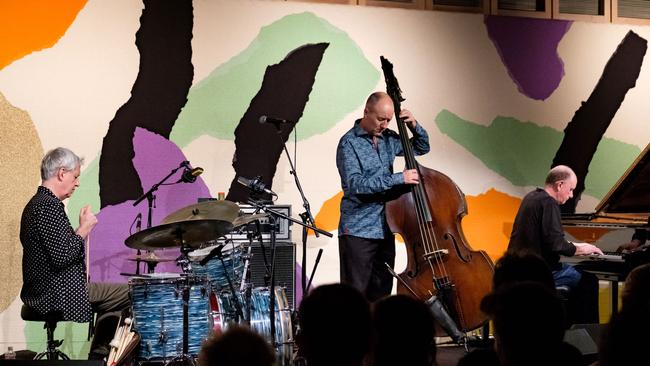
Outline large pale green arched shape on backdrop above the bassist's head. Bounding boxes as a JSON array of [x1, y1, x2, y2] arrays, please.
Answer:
[[170, 12, 380, 147]]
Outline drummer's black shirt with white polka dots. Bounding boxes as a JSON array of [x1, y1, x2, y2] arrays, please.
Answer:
[[20, 186, 91, 322]]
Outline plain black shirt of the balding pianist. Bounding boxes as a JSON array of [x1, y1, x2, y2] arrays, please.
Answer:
[[508, 188, 576, 270]]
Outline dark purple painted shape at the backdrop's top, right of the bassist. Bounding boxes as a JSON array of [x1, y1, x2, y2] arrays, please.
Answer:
[[485, 15, 572, 100]]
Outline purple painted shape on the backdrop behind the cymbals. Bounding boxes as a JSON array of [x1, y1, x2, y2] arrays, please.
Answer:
[[90, 128, 210, 283]]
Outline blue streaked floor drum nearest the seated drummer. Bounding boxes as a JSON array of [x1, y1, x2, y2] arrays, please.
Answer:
[[129, 273, 212, 360]]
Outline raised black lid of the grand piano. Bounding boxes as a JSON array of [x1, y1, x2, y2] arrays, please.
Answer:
[[595, 144, 650, 217]]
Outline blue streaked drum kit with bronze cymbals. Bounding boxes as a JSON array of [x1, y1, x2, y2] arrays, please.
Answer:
[[119, 200, 293, 366]]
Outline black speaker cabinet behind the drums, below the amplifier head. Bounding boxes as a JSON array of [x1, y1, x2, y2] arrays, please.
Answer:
[[249, 241, 296, 309]]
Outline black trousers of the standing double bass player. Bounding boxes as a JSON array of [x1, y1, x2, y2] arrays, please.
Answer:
[[339, 235, 395, 301]]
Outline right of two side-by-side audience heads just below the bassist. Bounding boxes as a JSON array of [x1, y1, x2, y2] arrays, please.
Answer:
[[373, 295, 436, 366]]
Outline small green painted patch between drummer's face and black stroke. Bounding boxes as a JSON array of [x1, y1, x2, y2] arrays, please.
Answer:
[[67, 157, 101, 220]]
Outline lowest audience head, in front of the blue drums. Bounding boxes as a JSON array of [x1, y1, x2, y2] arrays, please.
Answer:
[[199, 325, 275, 366]]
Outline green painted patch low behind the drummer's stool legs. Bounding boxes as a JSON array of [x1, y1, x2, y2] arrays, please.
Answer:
[[24, 322, 90, 360]]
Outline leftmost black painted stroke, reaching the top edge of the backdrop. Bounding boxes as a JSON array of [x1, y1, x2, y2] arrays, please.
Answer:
[[99, 0, 194, 208]]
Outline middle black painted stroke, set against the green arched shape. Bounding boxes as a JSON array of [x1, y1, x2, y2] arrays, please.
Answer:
[[226, 43, 329, 202]]
